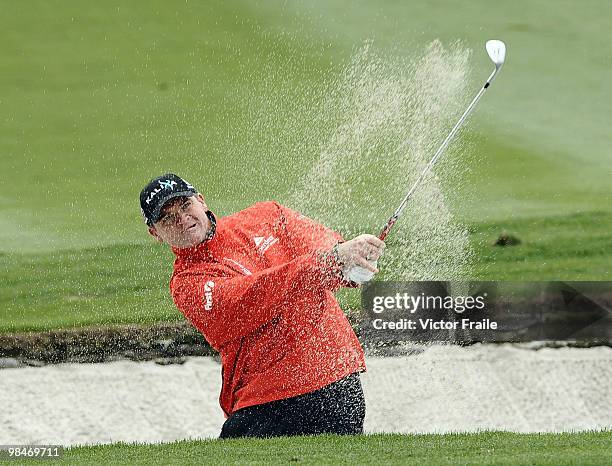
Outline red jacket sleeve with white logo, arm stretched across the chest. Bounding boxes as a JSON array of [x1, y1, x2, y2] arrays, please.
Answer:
[[170, 251, 341, 349]]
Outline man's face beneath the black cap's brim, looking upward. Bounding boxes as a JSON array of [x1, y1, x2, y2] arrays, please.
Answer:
[[149, 194, 211, 248]]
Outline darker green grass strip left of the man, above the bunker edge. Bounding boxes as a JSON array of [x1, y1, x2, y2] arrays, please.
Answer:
[[0, 245, 181, 332]]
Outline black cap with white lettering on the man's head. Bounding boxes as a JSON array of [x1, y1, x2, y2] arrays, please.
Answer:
[[140, 173, 198, 226]]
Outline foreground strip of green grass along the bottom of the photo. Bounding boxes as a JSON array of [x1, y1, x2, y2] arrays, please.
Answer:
[[64, 432, 612, 465]]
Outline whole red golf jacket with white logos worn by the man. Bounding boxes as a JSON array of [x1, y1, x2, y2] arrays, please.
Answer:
[[170, 202, 365, 416]]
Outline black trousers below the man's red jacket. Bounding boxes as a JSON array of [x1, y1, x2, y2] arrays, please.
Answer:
[[219, 373, 365, 439]]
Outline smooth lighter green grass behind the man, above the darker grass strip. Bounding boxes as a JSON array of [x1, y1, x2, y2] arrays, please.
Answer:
[[0, 0, 612, 252]]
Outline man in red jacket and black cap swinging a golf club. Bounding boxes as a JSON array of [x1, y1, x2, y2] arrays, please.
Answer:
[[140, 174, 384, 438]]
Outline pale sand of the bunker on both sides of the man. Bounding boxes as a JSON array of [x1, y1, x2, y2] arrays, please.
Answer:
[[0, 344, 612, 445]]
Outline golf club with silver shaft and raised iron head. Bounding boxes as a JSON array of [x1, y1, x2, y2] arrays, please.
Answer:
[[349, 40, 506, 283]]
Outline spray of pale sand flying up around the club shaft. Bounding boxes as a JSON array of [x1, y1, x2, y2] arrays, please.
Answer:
[[287, 41, 471, 280]]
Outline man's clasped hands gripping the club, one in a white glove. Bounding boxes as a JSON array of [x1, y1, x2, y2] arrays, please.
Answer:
[[337, 234, 385, 284]]
